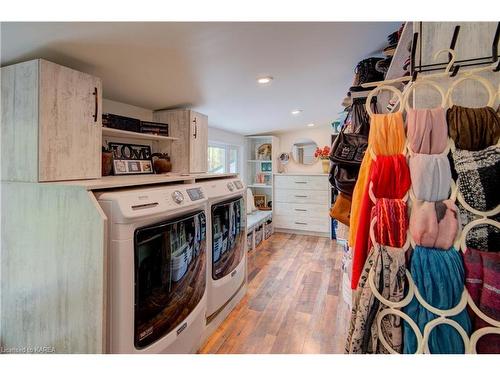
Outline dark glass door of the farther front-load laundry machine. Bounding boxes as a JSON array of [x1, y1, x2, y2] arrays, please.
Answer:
[[211, 197, 245, 280]]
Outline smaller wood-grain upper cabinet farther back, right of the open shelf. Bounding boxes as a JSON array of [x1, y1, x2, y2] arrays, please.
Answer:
[[153, 109, 208, 173]]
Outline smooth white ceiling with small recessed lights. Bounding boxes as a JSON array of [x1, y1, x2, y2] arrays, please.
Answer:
[[1, 22, 400, 134]]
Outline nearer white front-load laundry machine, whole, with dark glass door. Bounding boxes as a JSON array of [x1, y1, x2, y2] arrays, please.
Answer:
[[96, 185, 207, 353]]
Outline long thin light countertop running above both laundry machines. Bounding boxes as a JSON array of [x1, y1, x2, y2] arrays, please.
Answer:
[[45, 173, 238, 190]]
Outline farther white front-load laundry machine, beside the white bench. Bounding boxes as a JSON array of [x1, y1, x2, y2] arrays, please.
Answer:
[[200, 178, 246, 323]]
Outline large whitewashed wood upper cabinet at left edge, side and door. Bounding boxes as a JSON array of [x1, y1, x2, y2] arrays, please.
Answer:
[[1, 59, 102, 182]]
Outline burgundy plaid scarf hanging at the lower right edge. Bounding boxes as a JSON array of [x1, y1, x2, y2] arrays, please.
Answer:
[[463, 248, 500, 354]]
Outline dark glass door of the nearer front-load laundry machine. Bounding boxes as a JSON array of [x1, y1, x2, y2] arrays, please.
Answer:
[[134, 211, 206, 349]]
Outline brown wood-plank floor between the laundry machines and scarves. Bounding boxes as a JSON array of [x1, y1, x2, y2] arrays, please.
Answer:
[[200, 233, 350, 354]]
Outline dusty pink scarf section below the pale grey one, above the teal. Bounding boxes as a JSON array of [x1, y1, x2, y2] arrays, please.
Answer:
[[410, 199, 458, 250]]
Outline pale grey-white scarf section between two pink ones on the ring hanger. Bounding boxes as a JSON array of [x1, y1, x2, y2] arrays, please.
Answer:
[[409, 154, 451, 202]]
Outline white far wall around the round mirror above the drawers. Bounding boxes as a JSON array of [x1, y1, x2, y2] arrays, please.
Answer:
[[273, 125, 332, 173]]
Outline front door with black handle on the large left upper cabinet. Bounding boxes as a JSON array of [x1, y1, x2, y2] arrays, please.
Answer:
[[38, 60, 102, 181]]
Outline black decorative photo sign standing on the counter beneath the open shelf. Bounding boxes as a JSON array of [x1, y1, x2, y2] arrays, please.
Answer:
[[108, 142, 153, 175]]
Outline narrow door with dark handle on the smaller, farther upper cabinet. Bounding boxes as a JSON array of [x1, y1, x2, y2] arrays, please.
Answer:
[[189, 111, 208, 173]]
